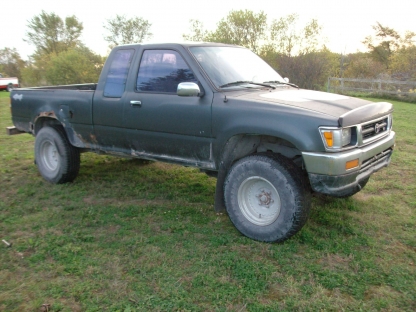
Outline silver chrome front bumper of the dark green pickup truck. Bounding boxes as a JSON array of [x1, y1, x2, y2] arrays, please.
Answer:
[[302, 131, 396, 196]]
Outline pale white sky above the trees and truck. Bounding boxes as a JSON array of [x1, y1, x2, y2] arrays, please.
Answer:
[[0, 0, 416, 59]]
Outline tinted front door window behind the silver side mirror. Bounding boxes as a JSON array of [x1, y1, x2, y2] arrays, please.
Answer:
[[137, 50, 198, 93]]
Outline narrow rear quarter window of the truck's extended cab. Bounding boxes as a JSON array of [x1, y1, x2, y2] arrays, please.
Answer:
[[104, 49, 134, 98]]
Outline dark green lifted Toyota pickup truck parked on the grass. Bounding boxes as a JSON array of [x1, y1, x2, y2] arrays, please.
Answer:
[[8, 43, 395, 242]]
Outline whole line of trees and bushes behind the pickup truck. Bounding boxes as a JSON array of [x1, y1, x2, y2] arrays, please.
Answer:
[[0, 10, 416, 90]]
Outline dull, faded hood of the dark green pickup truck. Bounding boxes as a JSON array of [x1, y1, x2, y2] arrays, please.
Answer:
[[237, 89, 393, 126]]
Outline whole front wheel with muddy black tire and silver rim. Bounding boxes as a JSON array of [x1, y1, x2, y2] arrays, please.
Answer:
[[224, 155, 310, 242]]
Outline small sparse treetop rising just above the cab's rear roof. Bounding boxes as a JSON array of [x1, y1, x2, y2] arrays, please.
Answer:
[[104, 15, 153, 48]]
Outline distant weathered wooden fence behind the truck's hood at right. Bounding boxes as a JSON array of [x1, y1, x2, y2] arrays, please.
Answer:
[[328, 77, 416, 98]]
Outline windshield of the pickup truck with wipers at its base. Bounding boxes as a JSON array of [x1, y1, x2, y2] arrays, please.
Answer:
[[190, 47, 284, 88]]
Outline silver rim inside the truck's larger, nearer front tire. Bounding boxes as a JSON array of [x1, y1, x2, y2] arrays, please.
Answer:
[[238, 176, 281, 226]]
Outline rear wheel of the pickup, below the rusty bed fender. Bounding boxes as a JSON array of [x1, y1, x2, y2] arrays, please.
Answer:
[[35, 126, 81, 184]]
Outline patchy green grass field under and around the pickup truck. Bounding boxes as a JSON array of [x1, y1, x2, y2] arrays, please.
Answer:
[[0, 92, 416, 312]]
